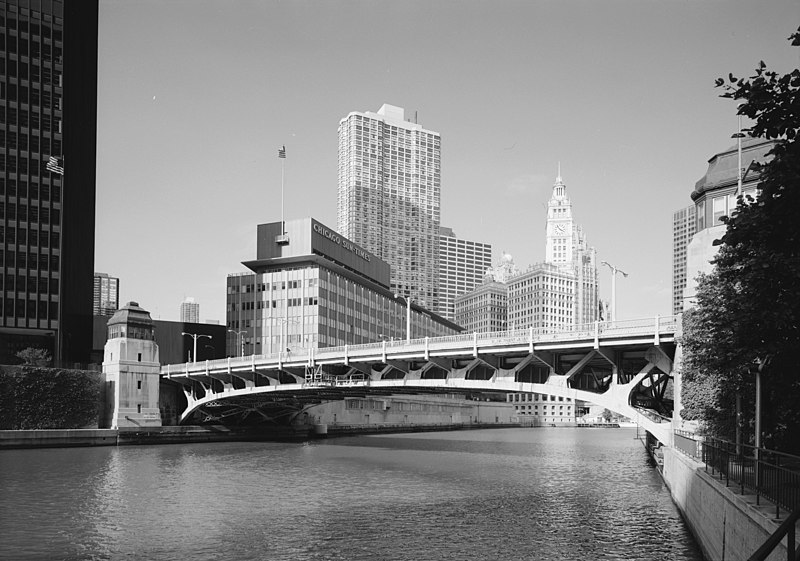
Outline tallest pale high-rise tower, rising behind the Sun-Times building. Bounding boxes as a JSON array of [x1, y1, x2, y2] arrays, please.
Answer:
[[338, 104, 441, 311]]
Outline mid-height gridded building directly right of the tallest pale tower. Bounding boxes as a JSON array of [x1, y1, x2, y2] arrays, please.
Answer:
[[439, 227, 492, 320]]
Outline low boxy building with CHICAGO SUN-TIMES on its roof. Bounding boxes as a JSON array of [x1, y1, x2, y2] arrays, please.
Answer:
[[226, 218, 461, 356]]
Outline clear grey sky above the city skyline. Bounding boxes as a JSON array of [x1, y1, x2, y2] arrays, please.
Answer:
[[95, 0, 800, 324]]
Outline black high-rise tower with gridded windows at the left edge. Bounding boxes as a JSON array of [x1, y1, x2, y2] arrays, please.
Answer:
[[0, 0, 98, 364]]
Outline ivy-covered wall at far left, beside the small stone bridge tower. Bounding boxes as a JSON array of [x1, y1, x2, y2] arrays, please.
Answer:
[[0, 366, 103, 430]]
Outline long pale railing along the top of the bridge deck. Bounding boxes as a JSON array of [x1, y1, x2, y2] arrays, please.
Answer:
[[161, 316, 679, 375]]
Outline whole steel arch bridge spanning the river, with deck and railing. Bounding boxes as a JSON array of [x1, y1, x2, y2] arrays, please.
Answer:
[[161, 316, 680, 444]]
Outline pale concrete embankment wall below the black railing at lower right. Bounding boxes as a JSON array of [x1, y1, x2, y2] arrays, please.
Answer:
[[659, 446, 786, 561]]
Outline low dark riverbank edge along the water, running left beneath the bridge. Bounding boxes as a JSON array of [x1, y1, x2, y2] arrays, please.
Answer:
[[0, 423, 520, 450]]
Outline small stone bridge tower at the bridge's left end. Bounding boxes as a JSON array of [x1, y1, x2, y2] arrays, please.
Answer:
[[103, 302, 161, 428]]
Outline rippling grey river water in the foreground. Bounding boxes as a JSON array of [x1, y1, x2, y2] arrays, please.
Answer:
[[0, 428, 702, 561]]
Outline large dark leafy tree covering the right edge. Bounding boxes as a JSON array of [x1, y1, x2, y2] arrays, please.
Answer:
[[682, 29, 800, 452]]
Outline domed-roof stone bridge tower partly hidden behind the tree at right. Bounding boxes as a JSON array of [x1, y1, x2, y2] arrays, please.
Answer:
[[683, 138, 775, 309]]
